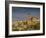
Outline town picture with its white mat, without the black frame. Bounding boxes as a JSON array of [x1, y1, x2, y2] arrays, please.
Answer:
[[9, 4, 43, 35]]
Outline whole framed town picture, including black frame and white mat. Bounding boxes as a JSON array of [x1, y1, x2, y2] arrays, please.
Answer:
[[6, 1, 45, 37]]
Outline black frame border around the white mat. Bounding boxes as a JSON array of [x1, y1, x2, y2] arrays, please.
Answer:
[[5, 1, 45, 38]]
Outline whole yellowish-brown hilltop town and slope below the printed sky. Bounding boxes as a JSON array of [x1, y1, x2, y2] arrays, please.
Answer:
[[12, 16, 40, 31]]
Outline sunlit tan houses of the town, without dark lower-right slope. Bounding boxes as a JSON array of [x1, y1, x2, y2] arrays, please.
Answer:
[[12, 17, 40, 30]]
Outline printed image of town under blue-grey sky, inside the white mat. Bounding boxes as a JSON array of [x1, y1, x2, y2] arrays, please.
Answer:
[[12, 7, 40, 31]]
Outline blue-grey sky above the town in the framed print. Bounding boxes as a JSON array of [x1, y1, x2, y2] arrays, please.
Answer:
[[12, 7, 40, 21]]
